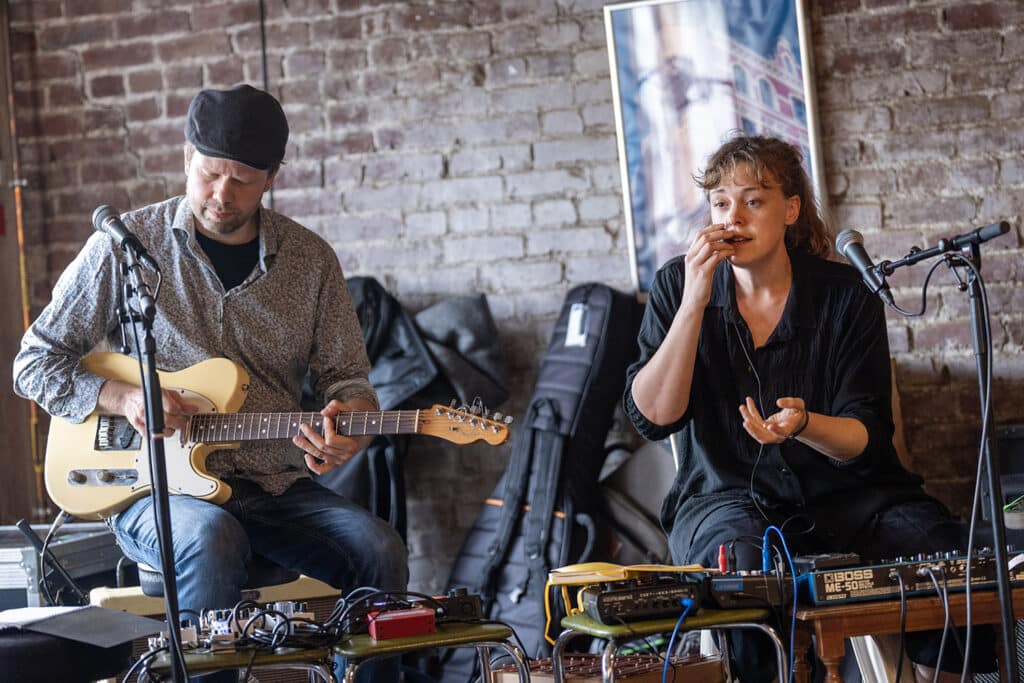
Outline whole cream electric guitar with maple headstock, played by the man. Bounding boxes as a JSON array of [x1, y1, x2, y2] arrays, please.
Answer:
[[45, 353, 509, 519]]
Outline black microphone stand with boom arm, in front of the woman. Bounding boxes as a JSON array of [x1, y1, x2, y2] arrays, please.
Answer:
[[873, 221, 1020, 681]]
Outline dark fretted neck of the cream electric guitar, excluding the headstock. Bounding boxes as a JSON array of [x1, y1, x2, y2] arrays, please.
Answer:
[[186, 411, 420, 443]]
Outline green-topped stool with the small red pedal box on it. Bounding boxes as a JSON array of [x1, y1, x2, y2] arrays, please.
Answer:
[[334, 623, 529, 683]]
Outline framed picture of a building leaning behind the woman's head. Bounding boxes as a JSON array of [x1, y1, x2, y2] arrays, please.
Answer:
[[604, 0, 825, 293]]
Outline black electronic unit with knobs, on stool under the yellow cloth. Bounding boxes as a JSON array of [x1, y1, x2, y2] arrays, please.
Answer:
[[580, 573, 707, 625]]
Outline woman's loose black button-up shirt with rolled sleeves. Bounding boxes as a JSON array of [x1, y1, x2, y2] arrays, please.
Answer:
[[625, 251, 927, 546]]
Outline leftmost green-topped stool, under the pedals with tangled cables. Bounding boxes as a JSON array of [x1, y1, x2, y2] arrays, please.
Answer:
[[150, 647, 338, 683]]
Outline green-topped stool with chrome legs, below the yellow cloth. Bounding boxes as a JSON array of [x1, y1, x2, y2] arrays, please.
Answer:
[[551, 609, 787, 683]]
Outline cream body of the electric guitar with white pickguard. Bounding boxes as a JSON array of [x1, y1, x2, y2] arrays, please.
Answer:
[[44, 353, 249, 519]]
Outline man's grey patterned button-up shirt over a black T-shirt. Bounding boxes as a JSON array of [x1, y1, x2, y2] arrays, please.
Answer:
[[14, 197, 377, 494]]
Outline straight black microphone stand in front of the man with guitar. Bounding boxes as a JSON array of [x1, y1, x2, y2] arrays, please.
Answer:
[[121, 243, 185, 683]]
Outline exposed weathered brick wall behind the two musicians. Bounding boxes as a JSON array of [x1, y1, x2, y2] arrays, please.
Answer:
[[11, 0, 1024, 590]]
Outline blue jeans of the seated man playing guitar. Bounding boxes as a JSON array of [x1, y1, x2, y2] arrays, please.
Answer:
[[112, 478, 409, 683]]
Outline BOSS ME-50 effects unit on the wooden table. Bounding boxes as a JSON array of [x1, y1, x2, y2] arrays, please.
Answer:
[[798, 551, 1024, 605]]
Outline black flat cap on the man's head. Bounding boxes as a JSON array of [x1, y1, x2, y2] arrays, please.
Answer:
[[185, 85, 288, 171]]
